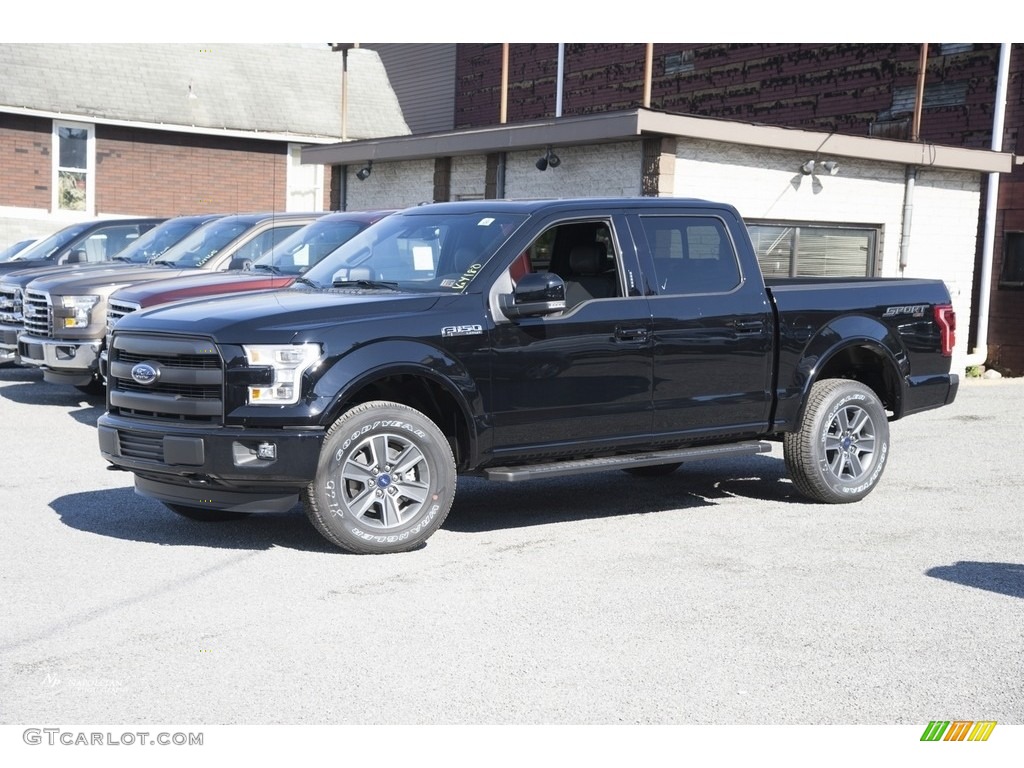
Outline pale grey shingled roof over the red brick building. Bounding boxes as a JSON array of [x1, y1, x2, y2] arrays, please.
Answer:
[[0, 43, 410, 142]]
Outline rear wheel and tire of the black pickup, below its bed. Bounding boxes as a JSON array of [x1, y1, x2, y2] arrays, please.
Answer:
[[783, 379, 889, 504]]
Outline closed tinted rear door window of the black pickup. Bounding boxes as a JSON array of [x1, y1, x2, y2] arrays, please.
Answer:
[[640, 216, 739, 295]]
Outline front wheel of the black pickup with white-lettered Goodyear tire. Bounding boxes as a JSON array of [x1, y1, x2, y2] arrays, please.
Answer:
[[303, 400, 456, 554]]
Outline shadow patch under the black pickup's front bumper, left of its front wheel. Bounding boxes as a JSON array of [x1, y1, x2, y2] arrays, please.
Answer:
[[50, 487, 344, 554]]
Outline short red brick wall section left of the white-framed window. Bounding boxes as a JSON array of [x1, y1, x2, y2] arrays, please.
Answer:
[[0, 115, 53, 210]]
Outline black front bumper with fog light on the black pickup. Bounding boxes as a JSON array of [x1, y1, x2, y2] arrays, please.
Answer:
[[96, 414, 324, 512]]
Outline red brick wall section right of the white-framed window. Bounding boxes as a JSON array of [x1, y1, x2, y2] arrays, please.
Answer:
[[96, 125, 288, 216]]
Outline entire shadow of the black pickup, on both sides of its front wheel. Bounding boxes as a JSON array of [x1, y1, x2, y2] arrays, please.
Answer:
[[50, 456, 805, 554]]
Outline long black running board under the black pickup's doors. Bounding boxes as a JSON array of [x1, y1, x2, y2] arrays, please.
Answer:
[[483, 440, 771, 482]]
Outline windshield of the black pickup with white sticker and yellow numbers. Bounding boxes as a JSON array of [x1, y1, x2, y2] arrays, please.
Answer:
[[296, 209, 526, 293]]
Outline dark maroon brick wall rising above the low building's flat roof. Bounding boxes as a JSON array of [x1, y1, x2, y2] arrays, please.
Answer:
[[456, 43, 998, 148]]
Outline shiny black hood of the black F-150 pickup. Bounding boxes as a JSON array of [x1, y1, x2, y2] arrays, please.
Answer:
[[117, 289, 440, 344]]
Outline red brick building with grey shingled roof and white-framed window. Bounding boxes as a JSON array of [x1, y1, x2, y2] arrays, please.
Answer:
[[0, 44, 409, 245]]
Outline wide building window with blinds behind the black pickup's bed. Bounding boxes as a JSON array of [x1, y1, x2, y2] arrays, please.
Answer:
[[748, 223, 879, 278]]
